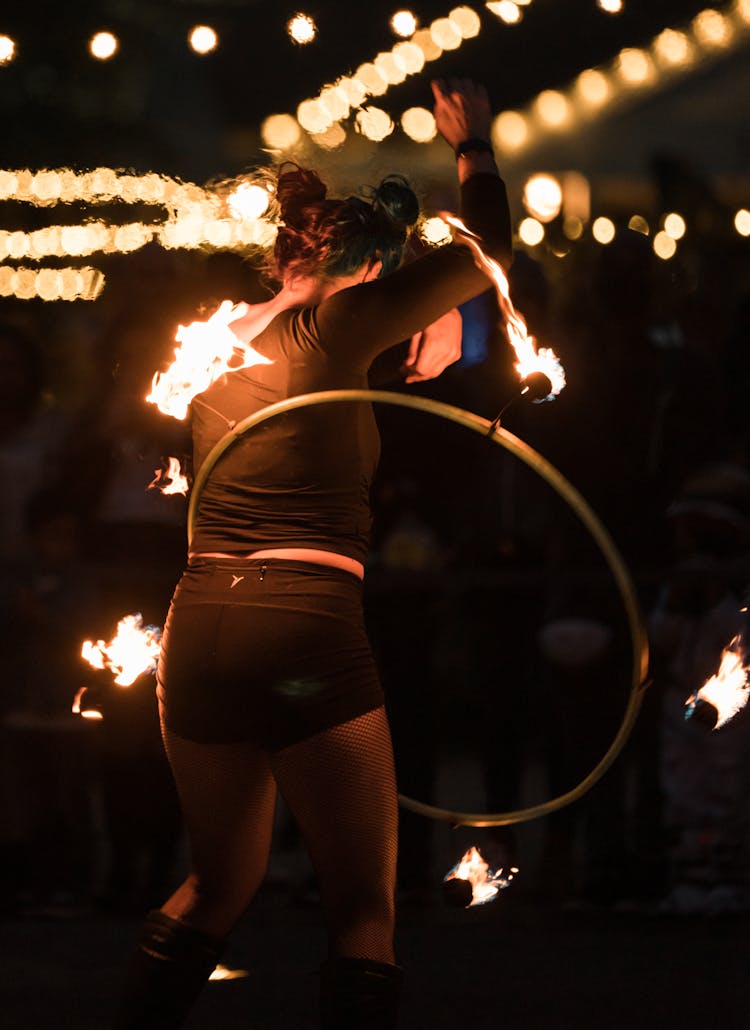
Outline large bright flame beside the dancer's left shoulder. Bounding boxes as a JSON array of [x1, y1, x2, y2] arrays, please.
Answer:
[[146, 301, 271, 419]]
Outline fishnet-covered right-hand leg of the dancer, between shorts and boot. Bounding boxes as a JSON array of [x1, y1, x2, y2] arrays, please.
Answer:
[[271, 708, 398, 963]]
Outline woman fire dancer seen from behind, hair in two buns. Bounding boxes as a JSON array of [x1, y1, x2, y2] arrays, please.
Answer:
[[115, 79, 511, 1030]]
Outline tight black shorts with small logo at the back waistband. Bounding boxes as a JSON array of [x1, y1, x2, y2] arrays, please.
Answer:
[[157, 558, 383, 751]]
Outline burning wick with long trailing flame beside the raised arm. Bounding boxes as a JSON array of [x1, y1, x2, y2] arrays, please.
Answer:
[[443, 214, 566, 433]]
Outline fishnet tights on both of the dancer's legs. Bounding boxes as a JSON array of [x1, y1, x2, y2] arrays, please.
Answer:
[[162, 708, 398, 962]]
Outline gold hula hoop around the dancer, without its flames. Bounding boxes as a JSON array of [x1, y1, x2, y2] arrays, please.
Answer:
[[188, 389, 648, 826]]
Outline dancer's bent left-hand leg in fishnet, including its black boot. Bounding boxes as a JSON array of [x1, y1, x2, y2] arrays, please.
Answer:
[[114, 725, 276, 1030]]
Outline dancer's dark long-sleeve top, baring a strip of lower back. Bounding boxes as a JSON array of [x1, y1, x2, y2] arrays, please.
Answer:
[[192, 173, 511, 561]]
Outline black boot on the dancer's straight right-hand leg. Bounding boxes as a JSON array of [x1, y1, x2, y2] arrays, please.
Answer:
[[320, 959, 404, 1030]]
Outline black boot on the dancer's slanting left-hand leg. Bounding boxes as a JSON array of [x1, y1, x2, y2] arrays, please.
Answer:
[[113, 909, 221, 1030]]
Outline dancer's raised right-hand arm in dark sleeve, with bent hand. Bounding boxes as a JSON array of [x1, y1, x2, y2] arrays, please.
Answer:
[[300, 79, 512, 371]]
